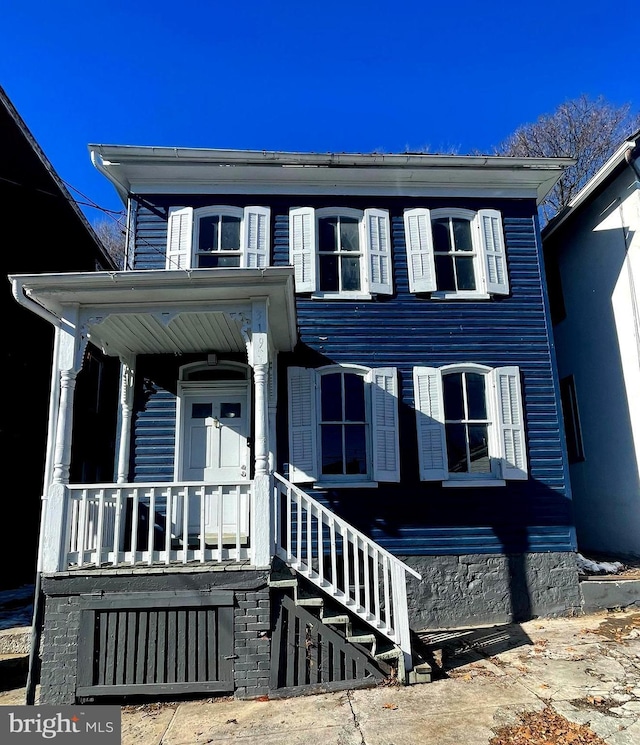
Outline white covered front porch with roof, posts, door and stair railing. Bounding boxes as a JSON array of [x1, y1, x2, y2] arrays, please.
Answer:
[[11, 267, 419, 670]]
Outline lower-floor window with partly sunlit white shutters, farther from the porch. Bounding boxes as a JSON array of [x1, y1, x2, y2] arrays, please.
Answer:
[[413, 364, 527, 486]]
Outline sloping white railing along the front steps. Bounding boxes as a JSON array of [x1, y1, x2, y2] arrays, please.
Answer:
[[274, 473, 421, 669]]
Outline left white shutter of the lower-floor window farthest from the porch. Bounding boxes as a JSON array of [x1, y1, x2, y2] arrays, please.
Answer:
[[413, 367, 449, 481]]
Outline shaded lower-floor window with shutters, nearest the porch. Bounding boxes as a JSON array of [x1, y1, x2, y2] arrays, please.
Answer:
[[289, 365, 400, 487]]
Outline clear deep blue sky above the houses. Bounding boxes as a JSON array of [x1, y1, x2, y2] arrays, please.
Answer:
[[0, 0, 640, 221]]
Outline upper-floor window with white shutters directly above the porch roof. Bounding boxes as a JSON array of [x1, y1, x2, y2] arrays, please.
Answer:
[[166, 205, 270, 269]]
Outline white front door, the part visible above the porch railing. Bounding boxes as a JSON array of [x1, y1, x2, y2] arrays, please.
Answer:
[[181, 387, 250, 483]]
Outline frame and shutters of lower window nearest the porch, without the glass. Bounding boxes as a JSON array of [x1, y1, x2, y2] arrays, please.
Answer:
[[288, 364, 400, 490]]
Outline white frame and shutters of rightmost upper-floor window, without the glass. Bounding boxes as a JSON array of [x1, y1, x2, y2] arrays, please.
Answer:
[[404, 207, 509, 301]]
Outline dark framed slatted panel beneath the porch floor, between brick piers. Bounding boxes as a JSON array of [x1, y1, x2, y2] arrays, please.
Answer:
[[76, 592, 234, 698]]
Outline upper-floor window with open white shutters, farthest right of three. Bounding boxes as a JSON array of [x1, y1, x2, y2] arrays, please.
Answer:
[[404, 207, 509, 300]]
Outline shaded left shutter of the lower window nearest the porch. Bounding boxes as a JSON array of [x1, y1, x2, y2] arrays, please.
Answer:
[[288, 367, 318, 484]]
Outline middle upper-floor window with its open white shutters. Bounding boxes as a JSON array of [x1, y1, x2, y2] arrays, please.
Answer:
[[289, 207, 393, 299]]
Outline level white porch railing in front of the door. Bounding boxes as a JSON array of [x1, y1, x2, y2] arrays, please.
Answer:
[[65, 482, 252, 568]]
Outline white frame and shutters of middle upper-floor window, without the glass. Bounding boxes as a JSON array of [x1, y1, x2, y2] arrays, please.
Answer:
[[289, 207, 393, 300]]
